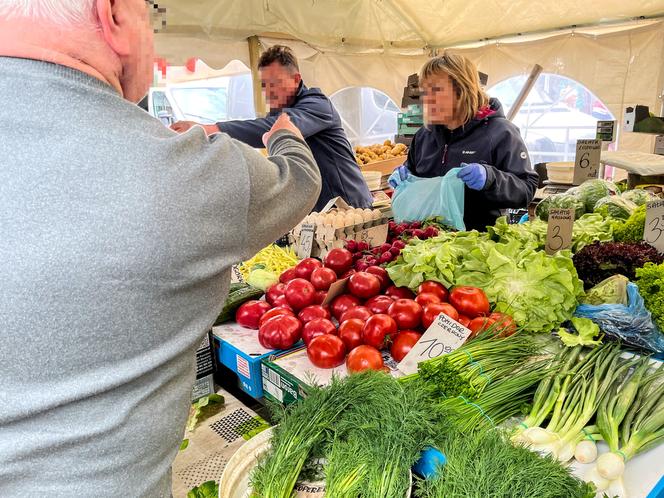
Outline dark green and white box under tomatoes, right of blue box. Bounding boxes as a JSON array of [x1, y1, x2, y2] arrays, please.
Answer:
[[261, 346, 402, 405]]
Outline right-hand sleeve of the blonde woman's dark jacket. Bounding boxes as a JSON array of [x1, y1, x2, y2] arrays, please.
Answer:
[[482, 127, 539, 208]]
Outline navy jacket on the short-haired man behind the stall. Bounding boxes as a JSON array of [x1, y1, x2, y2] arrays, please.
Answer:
[[217, 84, 373, 211]]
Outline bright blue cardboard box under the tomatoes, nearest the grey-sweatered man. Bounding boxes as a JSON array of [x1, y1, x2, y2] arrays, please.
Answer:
[[212, 323, 300, 399]]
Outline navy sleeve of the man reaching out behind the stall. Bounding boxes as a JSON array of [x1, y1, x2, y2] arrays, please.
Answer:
[[217, 98, 332, 147]]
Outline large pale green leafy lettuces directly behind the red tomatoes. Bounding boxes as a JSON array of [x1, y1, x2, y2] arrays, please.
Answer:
[[387, 232, 583, 332]]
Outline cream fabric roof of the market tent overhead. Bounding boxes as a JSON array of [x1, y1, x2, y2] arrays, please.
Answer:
[[159, 0, 664, 53]]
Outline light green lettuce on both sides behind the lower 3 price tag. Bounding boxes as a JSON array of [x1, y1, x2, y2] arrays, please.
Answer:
[[487, 214, 613, 253]]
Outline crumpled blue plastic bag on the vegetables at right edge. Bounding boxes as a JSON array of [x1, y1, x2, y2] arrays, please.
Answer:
[[574, 282, 664, 353]]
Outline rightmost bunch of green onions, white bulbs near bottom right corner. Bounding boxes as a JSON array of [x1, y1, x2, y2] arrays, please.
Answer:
[[586, 358, 664, 497]]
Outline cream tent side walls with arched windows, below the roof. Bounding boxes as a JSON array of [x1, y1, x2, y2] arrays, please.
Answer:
[[157, 22, 664, 152]]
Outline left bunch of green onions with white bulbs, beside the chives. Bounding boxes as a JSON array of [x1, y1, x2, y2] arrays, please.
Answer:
[[520, 344, 638, 462]]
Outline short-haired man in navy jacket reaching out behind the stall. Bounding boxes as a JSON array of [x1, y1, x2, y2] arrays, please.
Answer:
[[172, 45, 373, 211]]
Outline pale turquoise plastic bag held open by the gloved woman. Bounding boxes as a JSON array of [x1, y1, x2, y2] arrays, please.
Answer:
[[390, 168, 466, 230]]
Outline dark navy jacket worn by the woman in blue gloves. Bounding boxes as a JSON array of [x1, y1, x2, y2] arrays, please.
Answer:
[[406, 99, 538, 231]]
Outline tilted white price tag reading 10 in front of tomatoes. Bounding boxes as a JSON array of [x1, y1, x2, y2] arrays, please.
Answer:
[[397, 313, 472, 375]]
